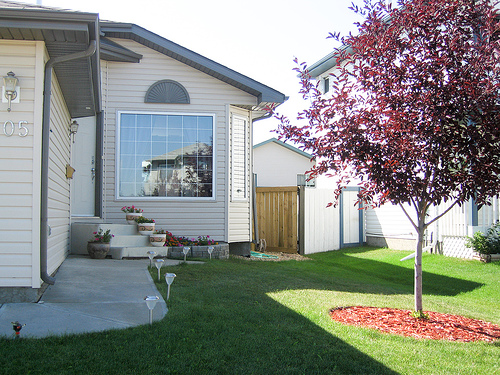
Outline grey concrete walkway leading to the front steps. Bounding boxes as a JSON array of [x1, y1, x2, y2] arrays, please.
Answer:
[[0, 256, 185, 338]]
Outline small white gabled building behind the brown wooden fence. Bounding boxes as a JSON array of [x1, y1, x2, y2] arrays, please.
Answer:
[[253, 138, 315, 187]]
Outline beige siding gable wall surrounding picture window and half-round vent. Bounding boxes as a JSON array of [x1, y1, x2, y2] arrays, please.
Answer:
[[102, 39, 256, 241]]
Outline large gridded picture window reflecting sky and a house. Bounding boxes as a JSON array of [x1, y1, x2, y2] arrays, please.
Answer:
[[117, 112, 214, 198]]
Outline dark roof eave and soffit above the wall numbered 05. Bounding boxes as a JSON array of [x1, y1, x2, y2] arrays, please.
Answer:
[[0, 1, 101, 118]]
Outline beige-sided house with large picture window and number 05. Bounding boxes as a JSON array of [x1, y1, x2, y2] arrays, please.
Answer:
[[0, 1, 285, 302]]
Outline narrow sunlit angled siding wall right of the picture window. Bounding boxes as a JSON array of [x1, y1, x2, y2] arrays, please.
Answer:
[[229, 107, 251, 242]]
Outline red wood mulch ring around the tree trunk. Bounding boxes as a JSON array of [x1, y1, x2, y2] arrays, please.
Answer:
[[330, 306, 500, 342]]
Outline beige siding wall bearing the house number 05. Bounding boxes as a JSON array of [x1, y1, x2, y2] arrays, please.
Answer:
[[0, 41, 44, 288]]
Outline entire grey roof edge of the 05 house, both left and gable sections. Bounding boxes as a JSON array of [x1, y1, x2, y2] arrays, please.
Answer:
[[0, 0, 287, 118]]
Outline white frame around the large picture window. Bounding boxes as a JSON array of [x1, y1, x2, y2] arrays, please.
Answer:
[[115, 111, 217, 202]]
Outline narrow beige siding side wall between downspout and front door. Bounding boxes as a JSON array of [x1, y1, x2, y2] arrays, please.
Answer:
[[47, 70, 71, 274]]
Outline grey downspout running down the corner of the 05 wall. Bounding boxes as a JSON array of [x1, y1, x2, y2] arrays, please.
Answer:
[[40, 40, 97, 285]]
